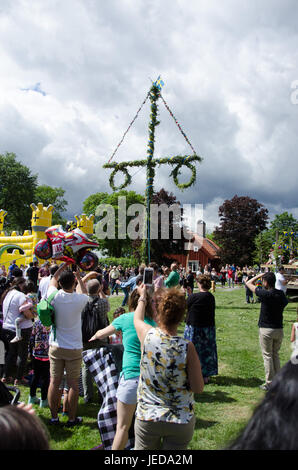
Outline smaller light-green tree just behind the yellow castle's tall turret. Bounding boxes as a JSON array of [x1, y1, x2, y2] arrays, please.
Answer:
[[34, 184, 67, 225]]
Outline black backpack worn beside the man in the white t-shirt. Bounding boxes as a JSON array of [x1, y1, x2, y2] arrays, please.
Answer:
[[82, 297, 109, 343]]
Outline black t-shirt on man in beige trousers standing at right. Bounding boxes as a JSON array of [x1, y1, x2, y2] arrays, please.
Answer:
[[255, 287, 288, 328]]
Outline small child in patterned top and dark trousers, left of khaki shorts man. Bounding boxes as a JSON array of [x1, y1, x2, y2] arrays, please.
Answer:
[[28, 319, 51, 408]]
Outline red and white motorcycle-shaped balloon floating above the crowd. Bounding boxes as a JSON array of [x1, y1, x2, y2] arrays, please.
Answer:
[[34, 225, 98, 271]]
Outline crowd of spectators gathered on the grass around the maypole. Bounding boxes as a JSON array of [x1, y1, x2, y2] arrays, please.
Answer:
[[0, 262, 298, 450]]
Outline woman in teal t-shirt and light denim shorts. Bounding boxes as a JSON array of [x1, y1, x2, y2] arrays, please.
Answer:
[[89, 289, 156, 450]]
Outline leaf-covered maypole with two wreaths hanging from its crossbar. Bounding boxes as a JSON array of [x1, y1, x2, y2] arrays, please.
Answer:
[[103, 76, 202, 263]]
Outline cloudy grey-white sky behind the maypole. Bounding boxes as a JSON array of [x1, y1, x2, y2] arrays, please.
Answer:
[[0, 0, 298, 230]]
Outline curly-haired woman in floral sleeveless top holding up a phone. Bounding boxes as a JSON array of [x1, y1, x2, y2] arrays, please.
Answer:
[[134, 284, 204, 450]]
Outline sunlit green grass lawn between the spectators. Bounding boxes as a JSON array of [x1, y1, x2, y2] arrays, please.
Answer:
[[15, 287, 297, 450]]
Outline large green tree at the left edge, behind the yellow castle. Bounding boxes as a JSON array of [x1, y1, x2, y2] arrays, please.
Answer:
[[0, 152, 37, 233]]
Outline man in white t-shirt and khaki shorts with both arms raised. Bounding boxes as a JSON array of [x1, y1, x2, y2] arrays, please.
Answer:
[[47, 263, 98, 426]]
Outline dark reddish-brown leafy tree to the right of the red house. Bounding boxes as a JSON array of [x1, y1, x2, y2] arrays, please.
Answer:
[[214, 195, 268, 266]]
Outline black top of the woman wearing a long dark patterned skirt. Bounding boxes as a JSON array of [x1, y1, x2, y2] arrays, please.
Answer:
[[186, 292, 215, 328]]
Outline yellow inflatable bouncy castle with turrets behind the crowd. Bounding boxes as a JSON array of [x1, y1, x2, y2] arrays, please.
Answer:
[[0, 202, 94, 269]]
